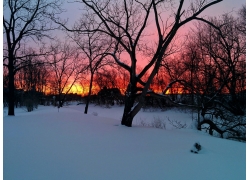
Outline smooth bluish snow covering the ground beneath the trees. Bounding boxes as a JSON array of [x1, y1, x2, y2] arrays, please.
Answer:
[[3, 105, 246, 180]]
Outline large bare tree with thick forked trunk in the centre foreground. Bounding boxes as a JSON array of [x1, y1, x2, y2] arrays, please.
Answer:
[[57, 0, 222, 127]]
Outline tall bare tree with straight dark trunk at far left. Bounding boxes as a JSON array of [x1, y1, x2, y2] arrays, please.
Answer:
[[3, 0, 62, 115]]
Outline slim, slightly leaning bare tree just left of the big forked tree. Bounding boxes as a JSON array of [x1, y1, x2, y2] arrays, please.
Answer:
[[72, 12, 111, 114]]
